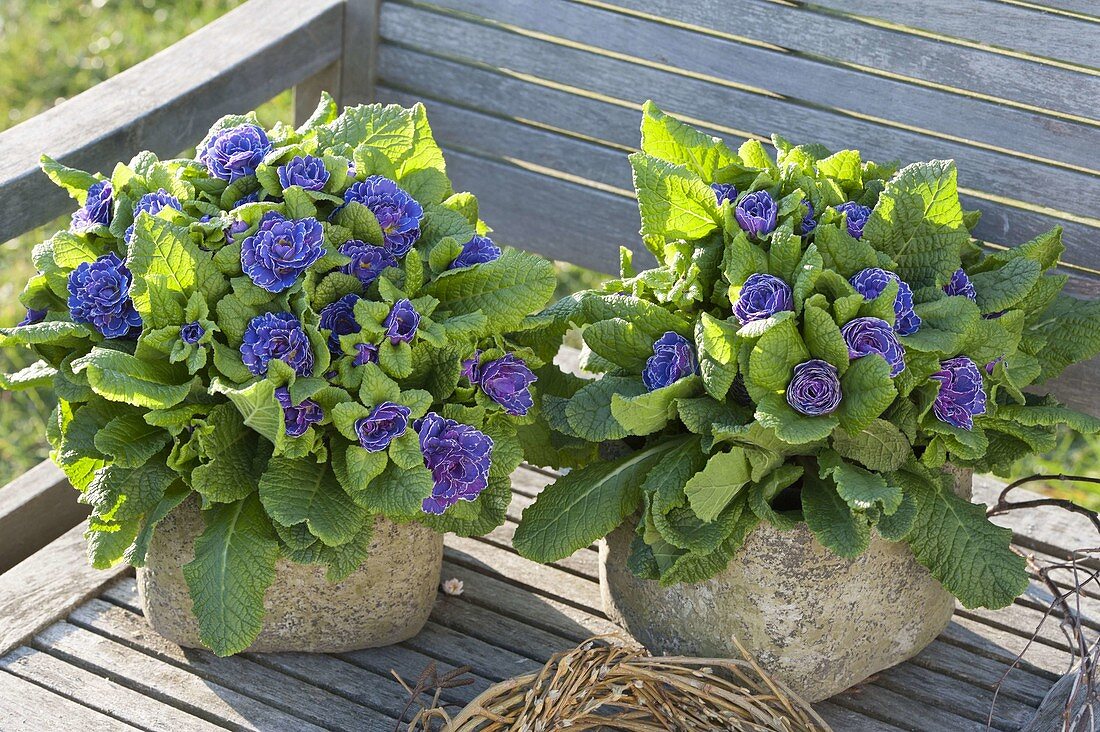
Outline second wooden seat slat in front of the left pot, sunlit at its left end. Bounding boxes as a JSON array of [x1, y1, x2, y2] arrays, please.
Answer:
[[35, 622, 325, 732]]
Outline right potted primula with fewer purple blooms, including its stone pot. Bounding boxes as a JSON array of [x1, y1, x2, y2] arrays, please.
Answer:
[[515, 103, 1100, 700]]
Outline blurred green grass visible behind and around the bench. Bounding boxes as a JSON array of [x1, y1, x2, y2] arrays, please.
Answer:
[[0, 0, 1100, 509]]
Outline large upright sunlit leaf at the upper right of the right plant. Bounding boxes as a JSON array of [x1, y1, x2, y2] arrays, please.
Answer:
[[862, 161, 970, 289]]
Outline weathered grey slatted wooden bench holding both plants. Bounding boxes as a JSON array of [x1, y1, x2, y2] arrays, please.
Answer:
[[0, 0, 1100, 731]]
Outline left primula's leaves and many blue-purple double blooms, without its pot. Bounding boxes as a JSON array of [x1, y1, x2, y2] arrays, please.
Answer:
[[0, 96, 554, 654]]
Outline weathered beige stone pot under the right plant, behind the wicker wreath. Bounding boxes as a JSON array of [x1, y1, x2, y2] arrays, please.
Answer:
[[600, 464, 971, 701]]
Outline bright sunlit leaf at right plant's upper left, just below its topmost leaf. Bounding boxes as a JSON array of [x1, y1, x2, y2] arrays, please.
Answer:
[[630, 153, 718, 239]]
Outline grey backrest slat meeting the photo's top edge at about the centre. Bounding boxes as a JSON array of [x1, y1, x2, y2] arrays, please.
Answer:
[[407, 0, 1100, 172]]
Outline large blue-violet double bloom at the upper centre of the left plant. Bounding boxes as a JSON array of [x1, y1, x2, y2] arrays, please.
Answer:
[[241, 211, 325, 293]]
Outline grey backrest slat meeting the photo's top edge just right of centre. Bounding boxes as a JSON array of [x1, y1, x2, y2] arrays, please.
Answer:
[[614, 0, 1096, 118]]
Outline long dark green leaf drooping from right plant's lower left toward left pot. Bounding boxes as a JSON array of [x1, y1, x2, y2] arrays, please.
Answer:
[[513, 440, 680, 562]]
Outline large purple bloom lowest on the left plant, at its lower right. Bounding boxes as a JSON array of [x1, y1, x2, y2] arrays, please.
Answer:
[[414, 412, 493, 515]]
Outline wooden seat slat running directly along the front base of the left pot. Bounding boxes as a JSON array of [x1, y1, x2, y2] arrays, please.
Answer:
[[68, 600, 393, 731]]
